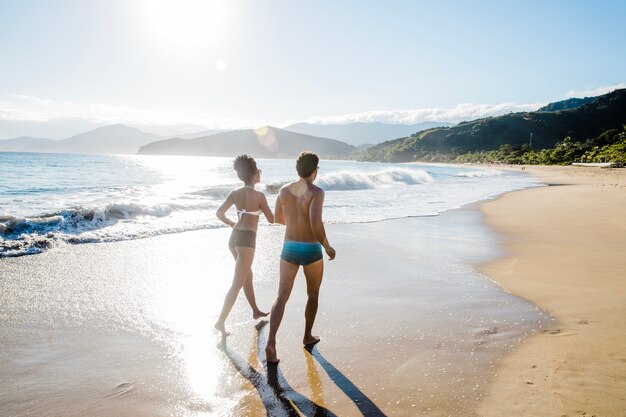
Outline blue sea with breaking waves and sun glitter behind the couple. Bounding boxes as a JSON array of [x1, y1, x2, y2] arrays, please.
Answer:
[[0, 153, 541, 257]]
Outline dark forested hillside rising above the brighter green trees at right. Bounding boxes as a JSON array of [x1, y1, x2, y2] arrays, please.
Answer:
[[359, 89, 626, 162]]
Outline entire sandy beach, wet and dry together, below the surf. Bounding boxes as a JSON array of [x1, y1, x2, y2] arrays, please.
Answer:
[[0, 167, 626, 417]]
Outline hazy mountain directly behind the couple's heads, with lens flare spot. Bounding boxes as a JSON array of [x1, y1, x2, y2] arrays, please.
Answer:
[[138, 126, 356, 158]]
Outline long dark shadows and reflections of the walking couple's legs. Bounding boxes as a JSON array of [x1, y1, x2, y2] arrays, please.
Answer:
[[220, 321, 385, 417]]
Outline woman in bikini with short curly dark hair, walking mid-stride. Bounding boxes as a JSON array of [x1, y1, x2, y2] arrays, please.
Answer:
[[215, 155, 274, 334]]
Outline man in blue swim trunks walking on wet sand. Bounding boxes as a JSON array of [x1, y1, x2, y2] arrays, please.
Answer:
[[265, 152, 335, 363]]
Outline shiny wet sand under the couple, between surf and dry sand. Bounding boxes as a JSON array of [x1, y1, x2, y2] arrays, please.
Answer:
[[0, 204, 554, 417]]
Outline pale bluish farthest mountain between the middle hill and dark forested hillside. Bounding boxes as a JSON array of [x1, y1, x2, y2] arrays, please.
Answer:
[[285, 122, 451, 146]]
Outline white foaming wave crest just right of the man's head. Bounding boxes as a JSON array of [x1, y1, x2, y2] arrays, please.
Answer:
[[315, 168, 433, 191]]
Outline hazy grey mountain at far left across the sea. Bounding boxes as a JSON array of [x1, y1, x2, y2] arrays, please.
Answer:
[[0, 124, 162, 154]]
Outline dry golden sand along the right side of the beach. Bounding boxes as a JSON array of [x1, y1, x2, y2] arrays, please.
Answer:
[[472, 167, 626, 417]]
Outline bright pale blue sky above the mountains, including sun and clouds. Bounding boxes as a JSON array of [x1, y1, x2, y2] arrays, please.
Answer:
[[0, 0, 626, 139]]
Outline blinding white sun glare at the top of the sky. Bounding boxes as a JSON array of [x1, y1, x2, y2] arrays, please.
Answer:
[[138, 0, 233, 55]]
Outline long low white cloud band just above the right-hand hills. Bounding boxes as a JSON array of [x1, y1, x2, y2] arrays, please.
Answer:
[[296, 103, 545, 124]]
